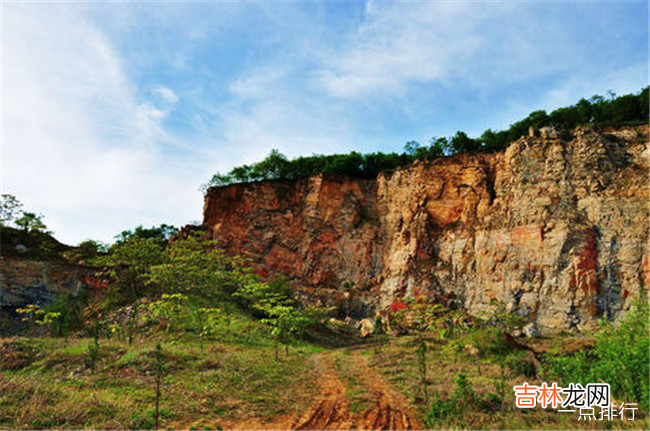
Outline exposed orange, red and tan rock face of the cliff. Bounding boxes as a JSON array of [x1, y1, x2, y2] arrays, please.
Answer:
[[204, 126, 650, 333]]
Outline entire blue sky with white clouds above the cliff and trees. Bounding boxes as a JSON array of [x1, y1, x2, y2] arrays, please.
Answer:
[[1, 1, 648, 243]]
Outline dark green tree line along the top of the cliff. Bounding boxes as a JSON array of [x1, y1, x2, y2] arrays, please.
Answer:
[[203, 87, 649, 190]]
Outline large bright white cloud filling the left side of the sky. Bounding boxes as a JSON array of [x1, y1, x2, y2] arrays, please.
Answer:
[[2, 3, 202, 243]]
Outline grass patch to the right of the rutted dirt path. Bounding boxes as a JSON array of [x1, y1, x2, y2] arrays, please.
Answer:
[[369, 333, 649, 429]]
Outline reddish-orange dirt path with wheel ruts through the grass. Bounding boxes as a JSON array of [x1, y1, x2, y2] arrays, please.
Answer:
[[292, 350, 421, 430]]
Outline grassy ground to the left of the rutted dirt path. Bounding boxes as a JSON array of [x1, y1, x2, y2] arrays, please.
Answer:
[[0, 338, 313, 429]]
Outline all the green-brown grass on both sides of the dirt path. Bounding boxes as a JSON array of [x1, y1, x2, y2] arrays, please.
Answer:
[[0, 322, 648, 429]]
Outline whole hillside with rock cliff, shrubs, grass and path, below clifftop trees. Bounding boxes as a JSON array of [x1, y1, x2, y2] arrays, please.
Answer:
[[0, 126, 650, 430]]
